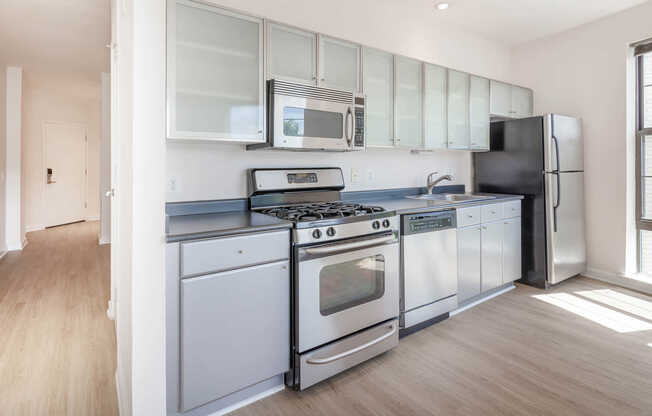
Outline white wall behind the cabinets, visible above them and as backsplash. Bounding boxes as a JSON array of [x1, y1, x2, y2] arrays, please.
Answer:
[[167, 0, 511, 201]]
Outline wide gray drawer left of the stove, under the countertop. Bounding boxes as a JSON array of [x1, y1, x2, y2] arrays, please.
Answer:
[[181, 230, 290, 276]]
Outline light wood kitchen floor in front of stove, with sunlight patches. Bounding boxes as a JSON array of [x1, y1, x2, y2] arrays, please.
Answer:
[[235, 278, 652, 416]]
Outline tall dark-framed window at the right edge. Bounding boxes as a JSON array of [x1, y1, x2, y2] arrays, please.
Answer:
[[636, 48, 652, 275]]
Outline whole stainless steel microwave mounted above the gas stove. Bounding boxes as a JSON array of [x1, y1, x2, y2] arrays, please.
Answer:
[[247, 79, 365, 152]]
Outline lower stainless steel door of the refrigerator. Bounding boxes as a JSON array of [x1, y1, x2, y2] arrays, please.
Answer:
[[545, 172, 586, 284]]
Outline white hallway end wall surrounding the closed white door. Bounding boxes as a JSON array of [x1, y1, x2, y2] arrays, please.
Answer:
[[23, 70, 101, 231]]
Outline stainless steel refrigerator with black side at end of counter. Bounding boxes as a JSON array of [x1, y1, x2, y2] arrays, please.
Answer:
[[473, 114, 586, 288]]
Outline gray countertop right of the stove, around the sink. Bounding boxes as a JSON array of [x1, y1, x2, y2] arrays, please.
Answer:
[[351, 193, 523, 215]]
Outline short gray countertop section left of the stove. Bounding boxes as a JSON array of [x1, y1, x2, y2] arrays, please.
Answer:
[[166, 211, 292, 243]]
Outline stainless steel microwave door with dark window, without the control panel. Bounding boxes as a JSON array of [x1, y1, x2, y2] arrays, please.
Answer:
[[272, 94, 355, 151]]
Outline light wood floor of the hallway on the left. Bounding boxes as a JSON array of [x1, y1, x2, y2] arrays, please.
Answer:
[[0, 222, 118, 415]]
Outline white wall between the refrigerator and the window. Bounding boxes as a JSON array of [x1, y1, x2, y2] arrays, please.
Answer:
[[512, 2, 652, 282]]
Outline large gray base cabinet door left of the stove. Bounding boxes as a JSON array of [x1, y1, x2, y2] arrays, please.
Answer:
[[179, 260, 290, 411]]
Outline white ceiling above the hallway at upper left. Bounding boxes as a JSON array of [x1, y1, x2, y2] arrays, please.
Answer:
[[0, 0, 111, 82]]
